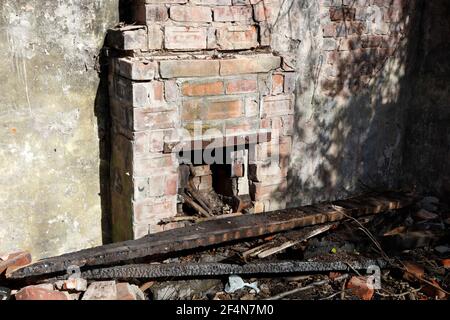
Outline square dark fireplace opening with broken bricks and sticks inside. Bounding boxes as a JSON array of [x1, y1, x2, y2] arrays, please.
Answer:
[[177, 146, 253, 218]]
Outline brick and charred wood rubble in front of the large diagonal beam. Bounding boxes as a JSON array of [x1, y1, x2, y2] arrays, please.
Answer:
[[0, 192, 450, 300]]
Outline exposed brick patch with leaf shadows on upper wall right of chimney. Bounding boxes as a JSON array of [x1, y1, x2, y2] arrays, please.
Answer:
[[320, 0, 409, 97]]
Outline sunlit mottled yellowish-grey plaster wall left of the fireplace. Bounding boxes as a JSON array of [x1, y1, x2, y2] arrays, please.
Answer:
[[0, 0, 118, 258]]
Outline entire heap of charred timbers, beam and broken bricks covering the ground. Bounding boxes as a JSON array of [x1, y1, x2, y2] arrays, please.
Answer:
[[0, 193, 450, 301]]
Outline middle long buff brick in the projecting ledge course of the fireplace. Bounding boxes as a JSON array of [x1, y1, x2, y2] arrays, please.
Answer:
[[160, 60, 220, 78]]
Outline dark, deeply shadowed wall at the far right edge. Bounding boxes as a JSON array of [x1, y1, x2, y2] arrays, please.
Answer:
[[404, 0, 450, 201]]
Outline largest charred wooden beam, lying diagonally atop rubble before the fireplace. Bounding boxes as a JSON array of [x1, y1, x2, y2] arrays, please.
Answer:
[[9, 193, 414, 279]]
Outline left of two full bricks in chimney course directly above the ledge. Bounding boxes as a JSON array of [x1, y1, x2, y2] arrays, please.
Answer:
[[164, 26, 207, 51]]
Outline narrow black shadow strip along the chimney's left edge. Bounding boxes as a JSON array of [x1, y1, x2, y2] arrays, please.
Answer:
[[94, 0, 131, 244]]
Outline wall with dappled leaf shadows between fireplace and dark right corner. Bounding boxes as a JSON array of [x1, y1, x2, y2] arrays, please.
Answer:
[[268, 0, 424, 207]]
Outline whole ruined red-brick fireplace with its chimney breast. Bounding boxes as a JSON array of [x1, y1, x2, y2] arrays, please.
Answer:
[[108, 0, 296, 240]]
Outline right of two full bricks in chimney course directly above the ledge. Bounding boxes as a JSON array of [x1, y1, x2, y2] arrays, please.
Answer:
[[217, 26, 258, 50]]
